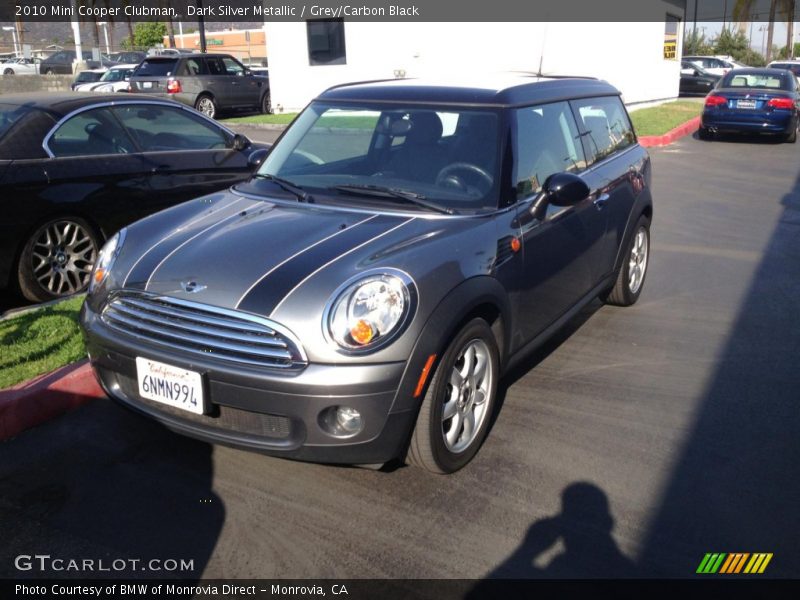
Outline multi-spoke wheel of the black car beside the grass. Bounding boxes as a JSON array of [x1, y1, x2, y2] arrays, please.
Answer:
[[17, 217, 100, 302]]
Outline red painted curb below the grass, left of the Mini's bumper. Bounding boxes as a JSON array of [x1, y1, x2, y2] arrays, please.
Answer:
[[0, 360, 105, 441]]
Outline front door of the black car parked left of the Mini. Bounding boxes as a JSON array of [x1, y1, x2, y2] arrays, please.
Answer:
[[113, 103, 250, 206]]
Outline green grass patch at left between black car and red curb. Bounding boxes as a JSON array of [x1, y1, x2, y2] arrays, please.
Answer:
[[0, 296, 86, 389]]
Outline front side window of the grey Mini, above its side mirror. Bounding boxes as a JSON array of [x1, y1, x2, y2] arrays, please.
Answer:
[[513, 102, 586, 198]]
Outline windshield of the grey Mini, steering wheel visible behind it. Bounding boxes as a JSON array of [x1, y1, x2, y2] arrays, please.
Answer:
[[258, 102, 499, 212]]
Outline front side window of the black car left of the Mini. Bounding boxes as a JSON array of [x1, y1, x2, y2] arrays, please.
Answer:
[[114, 104, 228, 152]]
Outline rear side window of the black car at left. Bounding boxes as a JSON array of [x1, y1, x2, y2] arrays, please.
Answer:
[[47, 108, 136, 158]]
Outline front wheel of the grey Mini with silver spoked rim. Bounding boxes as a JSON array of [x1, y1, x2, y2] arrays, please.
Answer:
[[406, 319, 500, 474]]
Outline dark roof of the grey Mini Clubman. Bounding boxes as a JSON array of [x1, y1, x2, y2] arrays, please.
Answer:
[[317, 73, 620, 107]]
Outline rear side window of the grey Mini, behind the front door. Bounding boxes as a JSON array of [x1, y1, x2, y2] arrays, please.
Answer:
[[573, 96, 636, 164]]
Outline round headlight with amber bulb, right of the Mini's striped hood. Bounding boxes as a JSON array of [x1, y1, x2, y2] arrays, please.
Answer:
[[327, 272, 416, 350]]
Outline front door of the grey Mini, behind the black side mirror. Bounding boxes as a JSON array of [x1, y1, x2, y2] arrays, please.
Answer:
[[512, 102, 605, 341]]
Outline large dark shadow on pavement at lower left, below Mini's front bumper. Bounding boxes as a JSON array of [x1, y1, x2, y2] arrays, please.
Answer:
[[0, 399, 225, 579]]
